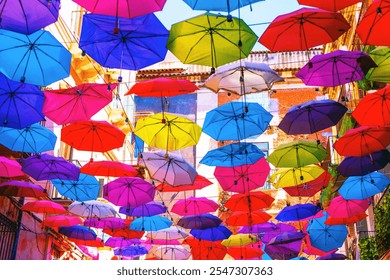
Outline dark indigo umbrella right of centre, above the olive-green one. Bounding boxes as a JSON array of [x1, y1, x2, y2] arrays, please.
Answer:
[[278, 99, 348, 135]]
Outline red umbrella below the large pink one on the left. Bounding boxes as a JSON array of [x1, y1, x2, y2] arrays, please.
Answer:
[[61, 120, 126, 152]]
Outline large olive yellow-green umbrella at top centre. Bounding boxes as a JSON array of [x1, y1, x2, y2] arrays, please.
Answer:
[[167, 13, 258, 72]]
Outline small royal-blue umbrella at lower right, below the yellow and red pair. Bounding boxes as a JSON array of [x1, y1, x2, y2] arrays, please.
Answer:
[[275, 203, 320, 222]]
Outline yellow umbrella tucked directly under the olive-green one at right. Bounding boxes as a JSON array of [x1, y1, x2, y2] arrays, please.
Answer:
[[268, 165, 325, 189]]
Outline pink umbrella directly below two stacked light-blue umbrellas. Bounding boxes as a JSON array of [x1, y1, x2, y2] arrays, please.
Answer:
[[214, 157, 271, 193]]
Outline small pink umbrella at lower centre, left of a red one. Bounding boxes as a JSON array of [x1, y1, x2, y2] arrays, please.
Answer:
[[171, 197, 218, 216]]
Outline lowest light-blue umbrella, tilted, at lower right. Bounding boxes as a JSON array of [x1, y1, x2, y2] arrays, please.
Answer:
[[307, 211, 348, 252]]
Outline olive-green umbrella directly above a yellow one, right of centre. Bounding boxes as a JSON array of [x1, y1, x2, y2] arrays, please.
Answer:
[[267, 140, 328, 168]]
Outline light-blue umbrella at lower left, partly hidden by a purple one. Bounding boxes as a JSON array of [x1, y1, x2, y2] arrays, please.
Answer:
[[51, 173, 100, 202]]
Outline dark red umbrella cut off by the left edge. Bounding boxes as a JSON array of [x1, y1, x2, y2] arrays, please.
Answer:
[[0, 180, 47, 197]]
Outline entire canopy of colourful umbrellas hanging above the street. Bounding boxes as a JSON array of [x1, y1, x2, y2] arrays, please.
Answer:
[[0, 0, 390, 259]]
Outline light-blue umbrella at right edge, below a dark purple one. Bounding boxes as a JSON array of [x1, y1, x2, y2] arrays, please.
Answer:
[[338, 172, 390, 199]]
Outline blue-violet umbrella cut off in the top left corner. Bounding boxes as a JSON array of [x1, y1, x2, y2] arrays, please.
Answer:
[[0, 0, 61, 34]]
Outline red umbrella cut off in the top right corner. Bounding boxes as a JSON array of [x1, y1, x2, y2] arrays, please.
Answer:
[[356, 0, 390, 46]]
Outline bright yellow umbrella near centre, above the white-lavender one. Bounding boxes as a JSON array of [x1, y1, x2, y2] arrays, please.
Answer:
[[134, 113, 202, 151]]
